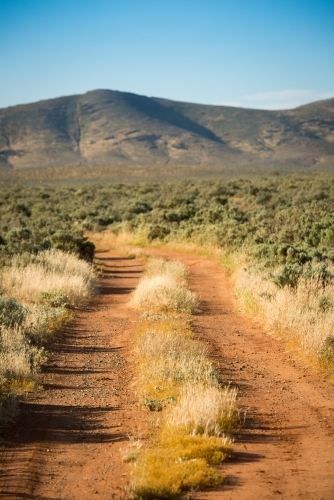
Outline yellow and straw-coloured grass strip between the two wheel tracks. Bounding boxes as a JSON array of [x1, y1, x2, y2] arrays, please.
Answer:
[[125, 259, 239, 500]]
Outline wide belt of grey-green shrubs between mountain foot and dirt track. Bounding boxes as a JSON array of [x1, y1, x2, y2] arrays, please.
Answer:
[[0, 173, 334, 272]]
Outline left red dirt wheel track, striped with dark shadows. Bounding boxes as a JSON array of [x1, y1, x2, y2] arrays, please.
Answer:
[[0, 254, 143, 500]]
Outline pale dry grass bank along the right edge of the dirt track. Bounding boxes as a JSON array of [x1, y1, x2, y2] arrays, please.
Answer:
[[236, 266, 334, 356]]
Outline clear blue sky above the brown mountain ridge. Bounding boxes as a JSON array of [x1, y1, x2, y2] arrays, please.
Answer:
[[0, 0, 334, 109]]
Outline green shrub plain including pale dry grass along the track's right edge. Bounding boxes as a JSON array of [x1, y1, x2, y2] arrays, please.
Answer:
[[0, 174, 334, 384]]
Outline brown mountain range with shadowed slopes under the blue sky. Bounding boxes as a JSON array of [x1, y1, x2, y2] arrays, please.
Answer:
[[0, 90, 334, 169]]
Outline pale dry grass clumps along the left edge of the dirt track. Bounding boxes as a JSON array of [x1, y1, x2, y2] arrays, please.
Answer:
[[0, 250, 96, 420]]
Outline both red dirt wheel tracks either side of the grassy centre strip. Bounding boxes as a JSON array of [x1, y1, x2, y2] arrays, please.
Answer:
[[0, 252, 334, 500]]
